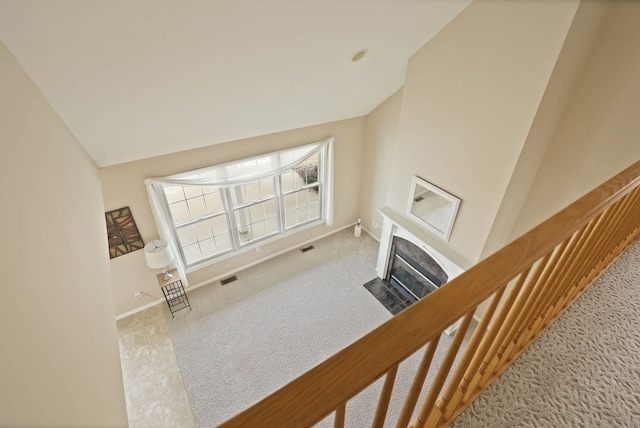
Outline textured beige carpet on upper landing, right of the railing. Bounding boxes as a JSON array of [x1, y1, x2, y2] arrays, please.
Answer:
[[452, 241, 640, 428]]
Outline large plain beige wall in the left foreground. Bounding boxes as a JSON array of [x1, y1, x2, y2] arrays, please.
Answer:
[[0, 43, 127, 427]]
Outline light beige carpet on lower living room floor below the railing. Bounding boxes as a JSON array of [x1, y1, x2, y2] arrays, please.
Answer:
[[169, 230, 464, 428]]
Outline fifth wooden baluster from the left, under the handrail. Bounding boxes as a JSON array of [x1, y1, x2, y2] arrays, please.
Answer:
[[436, 284, 507, 424]]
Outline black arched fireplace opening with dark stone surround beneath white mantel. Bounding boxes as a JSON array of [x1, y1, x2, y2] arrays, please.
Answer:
[[385, 236, 448, 304]]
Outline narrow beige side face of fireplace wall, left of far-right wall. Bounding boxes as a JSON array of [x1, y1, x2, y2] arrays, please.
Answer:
[[481, 0, 609, 258]]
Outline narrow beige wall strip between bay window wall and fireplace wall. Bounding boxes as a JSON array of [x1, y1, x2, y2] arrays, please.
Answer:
[[359, 89, 402, 238]]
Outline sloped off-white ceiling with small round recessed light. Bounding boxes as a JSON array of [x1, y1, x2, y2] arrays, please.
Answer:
[[0, 0, 471, 166]]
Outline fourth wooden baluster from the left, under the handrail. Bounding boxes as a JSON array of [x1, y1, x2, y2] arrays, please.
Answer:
[[413, 308, 476, 427]]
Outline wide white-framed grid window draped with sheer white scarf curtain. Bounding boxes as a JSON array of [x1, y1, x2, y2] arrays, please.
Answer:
[[145, 138, 333, 272]]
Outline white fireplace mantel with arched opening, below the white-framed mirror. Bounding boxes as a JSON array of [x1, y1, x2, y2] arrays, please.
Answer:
[[376, 207, 472, 281]]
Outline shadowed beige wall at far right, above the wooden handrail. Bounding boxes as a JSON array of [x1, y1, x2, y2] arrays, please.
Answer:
[[512, 1, 640, 237]]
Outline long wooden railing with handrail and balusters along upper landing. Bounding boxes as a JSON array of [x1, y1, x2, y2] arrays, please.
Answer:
[[222, 162, 640, 428]]
